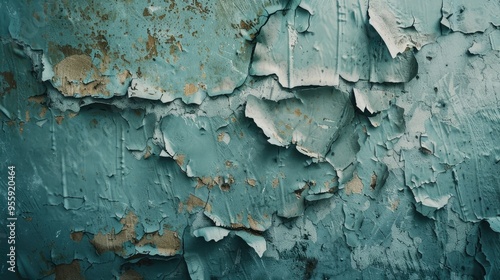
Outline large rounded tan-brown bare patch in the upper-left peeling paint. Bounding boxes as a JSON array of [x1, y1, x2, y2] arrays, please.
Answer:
[[52, 55, 110, 96]]
